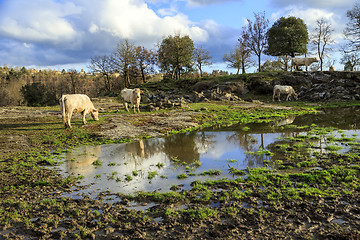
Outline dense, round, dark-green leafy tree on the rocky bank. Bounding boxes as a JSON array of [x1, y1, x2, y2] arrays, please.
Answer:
[[265, 17, 309, 70]]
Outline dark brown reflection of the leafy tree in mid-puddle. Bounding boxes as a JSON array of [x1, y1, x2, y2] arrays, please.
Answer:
[[163, 132, 215, 163]]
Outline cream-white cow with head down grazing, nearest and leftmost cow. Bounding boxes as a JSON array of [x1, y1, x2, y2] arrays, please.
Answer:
[[59, 94, 99, 128]]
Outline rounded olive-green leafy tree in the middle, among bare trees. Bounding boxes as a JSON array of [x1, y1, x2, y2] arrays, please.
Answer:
[[158, 34, 194, 79]]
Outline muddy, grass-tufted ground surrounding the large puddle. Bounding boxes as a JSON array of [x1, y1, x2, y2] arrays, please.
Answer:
[[0, 102, 360, 239]]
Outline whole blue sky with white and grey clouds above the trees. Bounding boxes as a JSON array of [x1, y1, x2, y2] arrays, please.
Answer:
[[0, 0, 356, 71]]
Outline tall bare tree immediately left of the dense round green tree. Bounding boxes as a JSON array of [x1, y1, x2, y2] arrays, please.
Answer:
[[243, 12, 269, 72]]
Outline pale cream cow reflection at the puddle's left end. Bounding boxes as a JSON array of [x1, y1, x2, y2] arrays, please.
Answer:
[[66, 145, 101, 175]]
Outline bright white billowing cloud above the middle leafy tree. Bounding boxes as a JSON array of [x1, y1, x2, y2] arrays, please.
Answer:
[[82, 0, 207, 42]]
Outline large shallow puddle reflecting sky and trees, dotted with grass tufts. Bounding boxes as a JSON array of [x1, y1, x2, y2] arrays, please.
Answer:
[[52, 108, 359, 197]]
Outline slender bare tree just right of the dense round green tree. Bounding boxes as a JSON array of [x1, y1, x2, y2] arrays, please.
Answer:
[[311, 18, 334, 71]]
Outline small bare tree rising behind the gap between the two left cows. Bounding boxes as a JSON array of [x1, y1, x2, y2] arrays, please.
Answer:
[[88, 55, 113, 92]]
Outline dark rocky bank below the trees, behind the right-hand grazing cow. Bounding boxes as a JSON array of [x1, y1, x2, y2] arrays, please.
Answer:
[[142, 71, 360, 110]]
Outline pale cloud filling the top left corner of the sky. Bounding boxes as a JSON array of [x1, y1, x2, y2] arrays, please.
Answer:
[[0, 0, 80, 44]]
